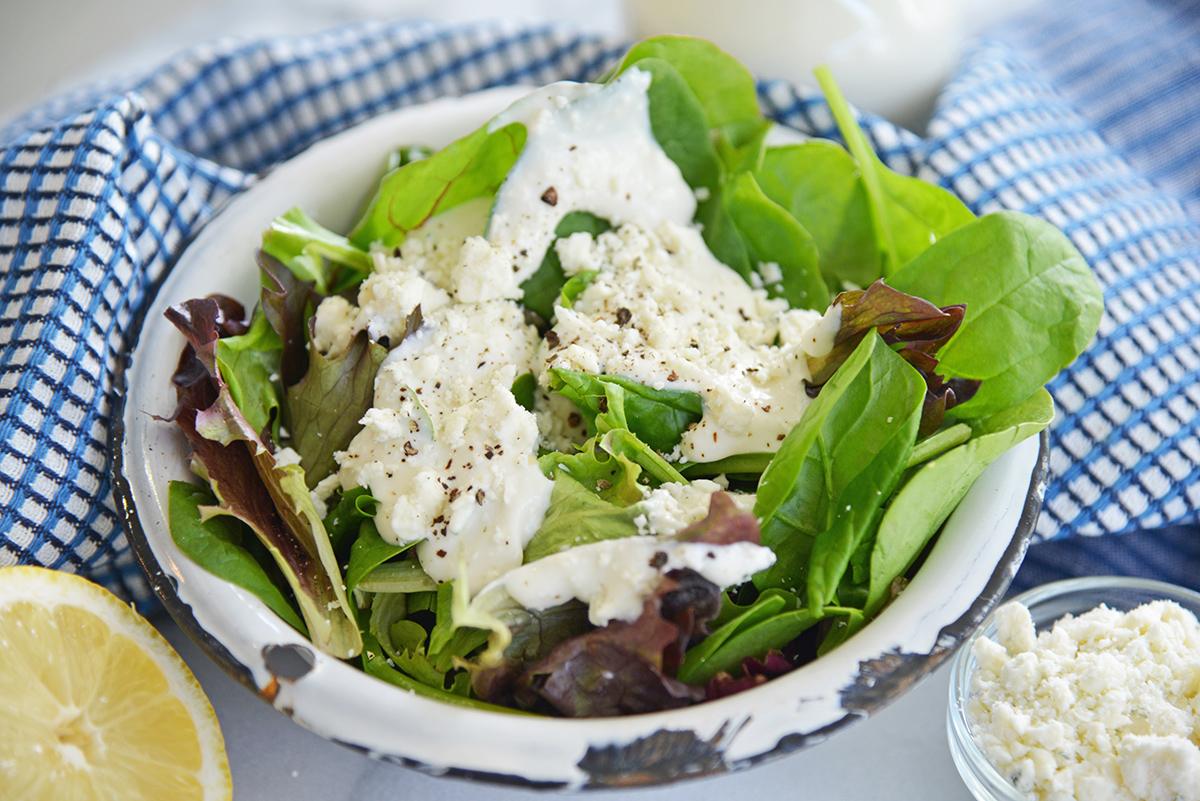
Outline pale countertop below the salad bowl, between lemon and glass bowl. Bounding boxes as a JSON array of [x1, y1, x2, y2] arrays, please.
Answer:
[[155, 615, 971, 801]]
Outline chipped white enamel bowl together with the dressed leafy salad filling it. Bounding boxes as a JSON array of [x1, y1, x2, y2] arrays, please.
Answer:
[[114, 37, 1102, 787]]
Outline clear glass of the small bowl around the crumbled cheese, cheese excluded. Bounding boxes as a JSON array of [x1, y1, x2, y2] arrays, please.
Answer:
[[947, 576, 1200, 801]]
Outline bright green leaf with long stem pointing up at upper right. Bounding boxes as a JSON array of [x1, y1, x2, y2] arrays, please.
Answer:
[[816, 66, 974, 277]]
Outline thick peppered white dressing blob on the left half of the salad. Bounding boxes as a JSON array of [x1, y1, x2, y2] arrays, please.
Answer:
[[341, 293, 553, 586]]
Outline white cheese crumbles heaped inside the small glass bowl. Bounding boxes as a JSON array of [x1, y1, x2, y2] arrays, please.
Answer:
[[967, 601, 1200, 801]]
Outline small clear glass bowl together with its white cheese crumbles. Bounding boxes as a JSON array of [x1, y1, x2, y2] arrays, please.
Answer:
[[948, 576, 1200, 801]]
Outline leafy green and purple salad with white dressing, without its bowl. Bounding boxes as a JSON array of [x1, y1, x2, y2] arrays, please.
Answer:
[[167, 37, 1102, 716]]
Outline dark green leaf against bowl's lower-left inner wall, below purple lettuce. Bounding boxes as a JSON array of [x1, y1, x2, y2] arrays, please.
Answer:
[[167, 481, 308, 637]]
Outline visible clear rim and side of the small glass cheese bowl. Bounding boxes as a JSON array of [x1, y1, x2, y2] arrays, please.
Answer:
[[946, 576, 1200, 801]]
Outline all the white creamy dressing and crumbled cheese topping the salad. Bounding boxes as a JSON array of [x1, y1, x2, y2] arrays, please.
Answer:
[[314, 70, 838, 622]]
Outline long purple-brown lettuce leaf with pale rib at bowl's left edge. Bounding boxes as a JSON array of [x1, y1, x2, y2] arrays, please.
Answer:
[[167, 299, 362, 658]]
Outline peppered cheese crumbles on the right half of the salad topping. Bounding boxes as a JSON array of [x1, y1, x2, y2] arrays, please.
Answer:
[[539, 222, 840, 462]]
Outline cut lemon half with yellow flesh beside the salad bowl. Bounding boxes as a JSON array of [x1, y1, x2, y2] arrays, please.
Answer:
[[0, 567, 233, 801]]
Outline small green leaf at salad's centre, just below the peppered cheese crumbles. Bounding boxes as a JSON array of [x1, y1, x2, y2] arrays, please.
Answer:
[[550, 367, 704, 453]]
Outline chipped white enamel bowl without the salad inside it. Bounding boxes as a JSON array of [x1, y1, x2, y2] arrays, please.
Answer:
[[113, 89, 1046, 788]]
